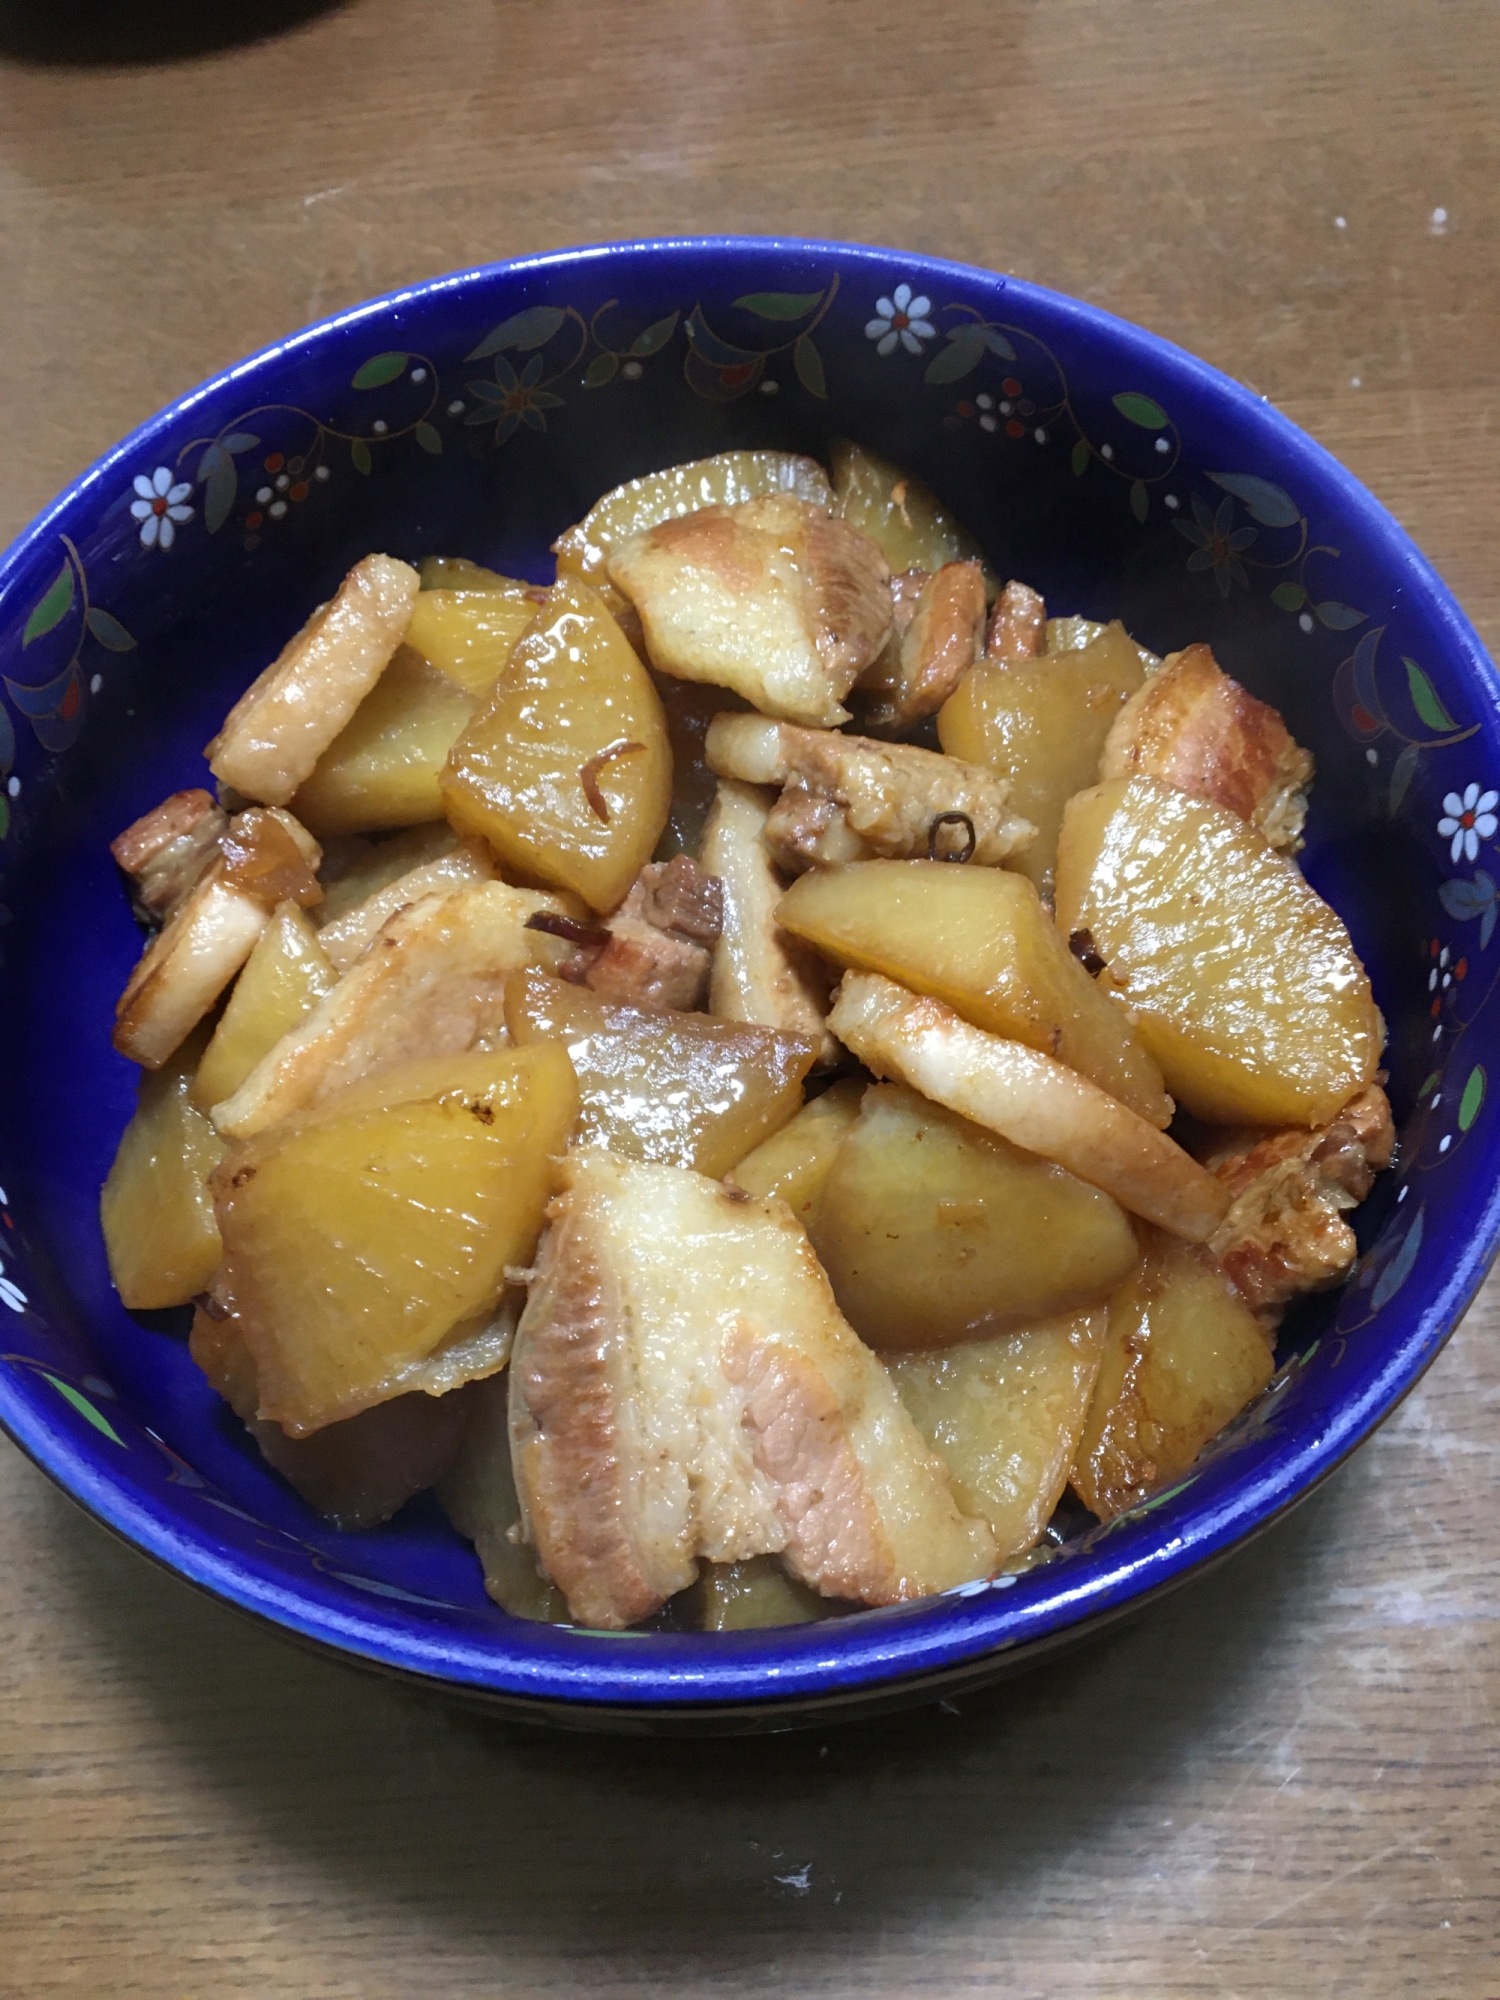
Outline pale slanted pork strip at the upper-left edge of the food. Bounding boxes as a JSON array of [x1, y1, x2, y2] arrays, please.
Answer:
[[204, 556, 420, 806]]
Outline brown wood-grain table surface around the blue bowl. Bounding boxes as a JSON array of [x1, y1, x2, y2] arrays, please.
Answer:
[[0, 0, 1500, 2000]]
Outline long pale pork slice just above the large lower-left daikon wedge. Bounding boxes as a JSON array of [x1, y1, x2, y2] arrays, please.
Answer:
[[212, 882, 574, 1138]]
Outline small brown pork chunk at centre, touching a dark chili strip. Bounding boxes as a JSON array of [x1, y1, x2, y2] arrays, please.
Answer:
[[560, 854, 724, 1012]]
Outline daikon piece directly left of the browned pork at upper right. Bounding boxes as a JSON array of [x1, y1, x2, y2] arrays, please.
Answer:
[[938, 624, 1146, 890]]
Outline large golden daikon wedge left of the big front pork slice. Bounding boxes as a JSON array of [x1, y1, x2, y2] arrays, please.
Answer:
[[212, 1048, 578, 1436]]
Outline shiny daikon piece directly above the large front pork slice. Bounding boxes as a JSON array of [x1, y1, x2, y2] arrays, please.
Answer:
[[506, 972, 818, 1174]]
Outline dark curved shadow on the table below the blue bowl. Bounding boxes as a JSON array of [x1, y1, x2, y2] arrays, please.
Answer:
[[26, 1474, 1360, 1992]]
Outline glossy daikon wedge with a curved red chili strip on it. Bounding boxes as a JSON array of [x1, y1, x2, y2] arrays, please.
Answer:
[[442, 576, 672, 912]]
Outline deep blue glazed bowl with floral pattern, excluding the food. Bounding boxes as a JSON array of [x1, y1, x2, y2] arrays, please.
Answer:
[[0, 240, 1500, 1732]]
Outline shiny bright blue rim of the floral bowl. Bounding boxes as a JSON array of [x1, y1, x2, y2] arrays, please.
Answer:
[[0, 234, 1500, 1720]]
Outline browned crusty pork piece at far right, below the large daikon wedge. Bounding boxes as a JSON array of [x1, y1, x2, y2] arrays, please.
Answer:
[[1202, 1084, 1396, 1330]]
